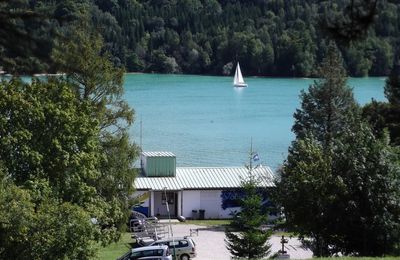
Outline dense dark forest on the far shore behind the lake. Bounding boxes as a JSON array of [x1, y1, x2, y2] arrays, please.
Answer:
[[0, 0, 400, 77]]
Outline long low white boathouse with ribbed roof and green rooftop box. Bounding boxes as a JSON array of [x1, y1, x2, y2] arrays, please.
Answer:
[[133, 152, 274, 219]]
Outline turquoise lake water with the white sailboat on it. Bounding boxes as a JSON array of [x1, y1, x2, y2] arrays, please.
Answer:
[[124, 74, 385, 169]]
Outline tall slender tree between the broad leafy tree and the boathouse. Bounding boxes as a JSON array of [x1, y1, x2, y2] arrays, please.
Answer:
[[54, 24, 139, 240]]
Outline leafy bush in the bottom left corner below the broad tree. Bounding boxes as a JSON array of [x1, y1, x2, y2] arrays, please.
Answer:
[[0, 170, 99, 260]]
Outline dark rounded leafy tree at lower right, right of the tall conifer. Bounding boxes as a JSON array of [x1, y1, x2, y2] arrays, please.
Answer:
[[333, 123, 400, 256]]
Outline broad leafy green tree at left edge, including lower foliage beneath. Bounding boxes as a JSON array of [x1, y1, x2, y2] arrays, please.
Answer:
[[0, 79, 107, 259]]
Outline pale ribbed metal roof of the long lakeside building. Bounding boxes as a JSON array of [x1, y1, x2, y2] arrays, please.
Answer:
[[134, 166, 275, 190]]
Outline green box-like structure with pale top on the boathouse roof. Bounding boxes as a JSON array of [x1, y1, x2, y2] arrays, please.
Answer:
[[142, 152, 176, 177]]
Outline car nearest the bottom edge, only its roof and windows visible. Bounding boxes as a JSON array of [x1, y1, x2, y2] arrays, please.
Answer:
[[117, 245, 172, 260]]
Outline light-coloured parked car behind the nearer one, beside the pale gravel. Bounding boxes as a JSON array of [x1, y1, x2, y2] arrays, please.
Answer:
[[151, 237, 196, 260]]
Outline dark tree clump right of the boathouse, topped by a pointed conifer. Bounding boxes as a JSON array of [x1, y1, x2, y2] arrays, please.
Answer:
[[276, 44, 400, 256]]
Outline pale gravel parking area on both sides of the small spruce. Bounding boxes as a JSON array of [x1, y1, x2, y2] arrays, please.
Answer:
[[172, 224, 312, 260]]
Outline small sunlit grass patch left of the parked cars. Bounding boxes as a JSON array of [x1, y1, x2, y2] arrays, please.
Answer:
[[96, 232, 133, 260]]
